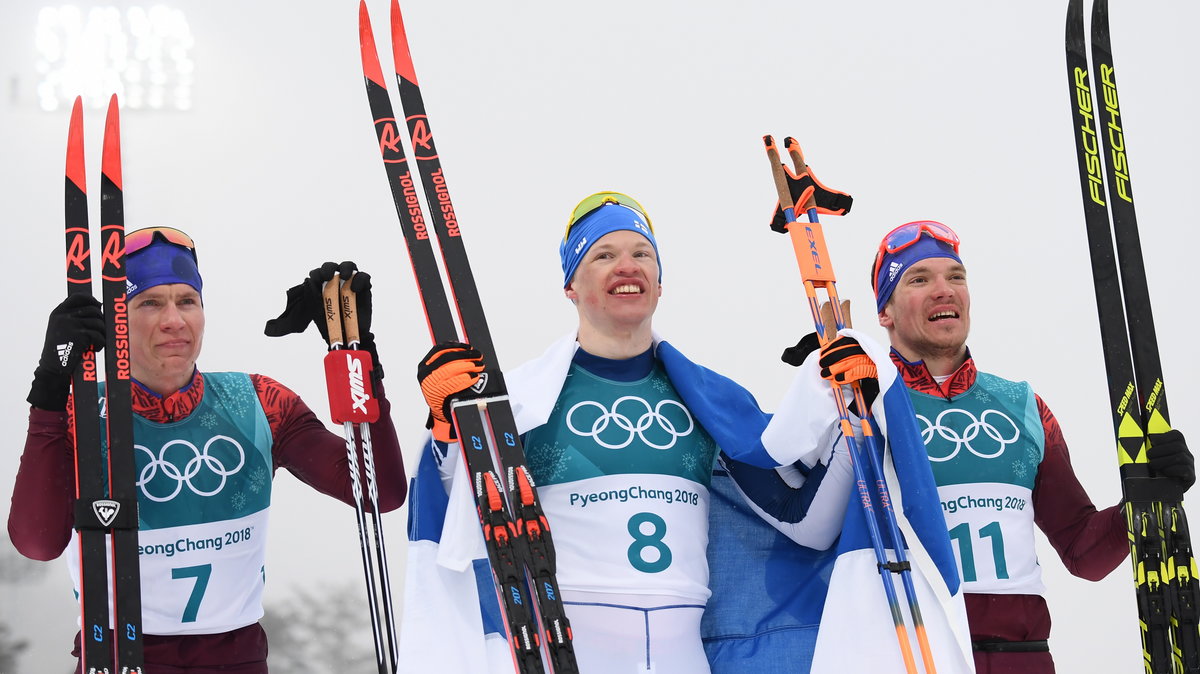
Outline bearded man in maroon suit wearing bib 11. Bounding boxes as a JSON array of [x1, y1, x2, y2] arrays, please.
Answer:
[[871, 221, 1195, 674]]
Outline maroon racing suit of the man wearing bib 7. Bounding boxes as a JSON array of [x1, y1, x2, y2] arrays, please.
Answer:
[[8, 371, 407, 674]]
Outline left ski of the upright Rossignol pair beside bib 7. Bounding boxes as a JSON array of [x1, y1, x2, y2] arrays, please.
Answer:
[[60, 97, 114, 674]]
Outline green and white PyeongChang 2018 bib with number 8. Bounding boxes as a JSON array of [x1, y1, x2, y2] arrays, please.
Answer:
[[524, 365, 716, 601]]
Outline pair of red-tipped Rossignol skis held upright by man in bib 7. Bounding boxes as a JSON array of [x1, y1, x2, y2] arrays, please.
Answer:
[[65, 95, 143, 674]]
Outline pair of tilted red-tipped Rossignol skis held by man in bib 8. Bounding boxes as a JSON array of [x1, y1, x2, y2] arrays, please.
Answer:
[[359, 0, 578, 674]]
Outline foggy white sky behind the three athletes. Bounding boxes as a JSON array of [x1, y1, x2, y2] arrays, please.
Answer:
[[0, 0, 1200, 672]]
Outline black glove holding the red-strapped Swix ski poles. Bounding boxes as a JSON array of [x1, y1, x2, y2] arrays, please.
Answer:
[[263, 260, 383, 380]]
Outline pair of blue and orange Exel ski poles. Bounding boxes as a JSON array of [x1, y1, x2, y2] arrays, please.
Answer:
[[763, 136, 936, 674]]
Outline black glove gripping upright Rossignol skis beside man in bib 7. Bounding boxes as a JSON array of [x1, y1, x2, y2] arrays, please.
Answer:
[[25, 295, 104, 411]]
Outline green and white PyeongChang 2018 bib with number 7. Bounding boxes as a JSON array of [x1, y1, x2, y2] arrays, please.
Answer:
[[67, 373, 271, 634]]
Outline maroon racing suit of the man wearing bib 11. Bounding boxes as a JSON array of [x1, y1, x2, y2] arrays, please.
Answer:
[[892, 349, 1129, 674]]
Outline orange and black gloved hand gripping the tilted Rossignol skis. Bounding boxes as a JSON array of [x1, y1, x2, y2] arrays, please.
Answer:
[[416, 342, 484, 443]]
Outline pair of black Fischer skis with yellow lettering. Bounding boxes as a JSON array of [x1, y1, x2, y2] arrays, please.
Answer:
[[1067, 0, 1200, 674]]
